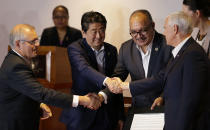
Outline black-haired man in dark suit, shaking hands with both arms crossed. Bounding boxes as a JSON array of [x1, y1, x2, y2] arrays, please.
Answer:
[[61, 11, 123, 130]]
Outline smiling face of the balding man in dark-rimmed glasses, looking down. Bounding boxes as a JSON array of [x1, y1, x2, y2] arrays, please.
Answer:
[[130, 13, 154, 46]]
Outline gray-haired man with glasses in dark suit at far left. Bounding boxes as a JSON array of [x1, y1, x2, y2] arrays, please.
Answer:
[[0, 24, 100, 130]]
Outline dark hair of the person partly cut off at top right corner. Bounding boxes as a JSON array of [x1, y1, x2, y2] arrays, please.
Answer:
[[183, 0, 210, 17]]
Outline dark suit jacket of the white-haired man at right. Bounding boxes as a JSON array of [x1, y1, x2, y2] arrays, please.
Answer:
[[130, 38, 210, 130]]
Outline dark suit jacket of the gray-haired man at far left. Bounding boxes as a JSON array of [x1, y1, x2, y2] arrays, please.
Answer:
[[0, 51, 73, 130]]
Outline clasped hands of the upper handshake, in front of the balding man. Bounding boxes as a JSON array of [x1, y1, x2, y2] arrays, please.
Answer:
[[105, 77, 129, 94]]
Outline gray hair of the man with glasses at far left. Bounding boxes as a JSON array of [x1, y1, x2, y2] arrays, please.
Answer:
[[9, 24, 35, 48]]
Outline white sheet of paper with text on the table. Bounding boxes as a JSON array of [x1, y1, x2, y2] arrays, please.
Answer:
[[131, 113, 164, 130]]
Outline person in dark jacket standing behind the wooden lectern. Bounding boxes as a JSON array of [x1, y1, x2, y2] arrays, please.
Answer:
[[40, 5, 82, 47]]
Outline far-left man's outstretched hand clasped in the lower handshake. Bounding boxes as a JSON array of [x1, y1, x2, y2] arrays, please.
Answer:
[[79, 93, 101, 110]]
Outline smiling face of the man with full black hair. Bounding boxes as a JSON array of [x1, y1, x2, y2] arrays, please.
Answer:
[[82, 23, 106, 50]]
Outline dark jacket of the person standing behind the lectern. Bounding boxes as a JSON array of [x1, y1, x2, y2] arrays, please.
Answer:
[[40, 26, 82, 47]]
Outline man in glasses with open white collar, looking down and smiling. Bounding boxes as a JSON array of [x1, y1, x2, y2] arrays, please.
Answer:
[[113, 10, 170, 110]]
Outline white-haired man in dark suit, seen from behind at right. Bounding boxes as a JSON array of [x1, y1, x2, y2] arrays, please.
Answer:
[[110, 12, 210, 130]]
